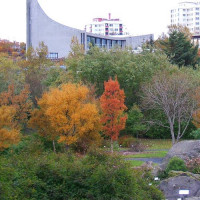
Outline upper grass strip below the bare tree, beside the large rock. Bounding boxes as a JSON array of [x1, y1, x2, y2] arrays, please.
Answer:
[[139, 139, 172, 150]]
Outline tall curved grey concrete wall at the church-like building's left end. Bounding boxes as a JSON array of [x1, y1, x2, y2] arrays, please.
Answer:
[[27, 0, 84, 58]]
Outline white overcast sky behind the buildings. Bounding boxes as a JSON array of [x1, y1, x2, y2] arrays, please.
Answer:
[[0, 0, 184, 42]]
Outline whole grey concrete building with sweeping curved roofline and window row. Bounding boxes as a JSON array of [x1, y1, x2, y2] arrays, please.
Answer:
[[26, 0, 154, 59]]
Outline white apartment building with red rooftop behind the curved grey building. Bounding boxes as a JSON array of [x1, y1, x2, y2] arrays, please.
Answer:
[[85, 13, 129, 36]]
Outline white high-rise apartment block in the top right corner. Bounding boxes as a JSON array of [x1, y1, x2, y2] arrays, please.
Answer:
[[171, 1, 200, 35]]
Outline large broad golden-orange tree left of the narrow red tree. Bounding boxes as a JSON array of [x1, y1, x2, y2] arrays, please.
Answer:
[[30, 83, 101, 152]]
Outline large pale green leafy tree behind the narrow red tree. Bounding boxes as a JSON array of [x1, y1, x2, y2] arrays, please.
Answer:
[[77, 47, 171, 109]]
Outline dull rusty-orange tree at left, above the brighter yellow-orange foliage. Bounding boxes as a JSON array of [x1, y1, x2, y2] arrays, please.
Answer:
[[0, 84, 32, 126]]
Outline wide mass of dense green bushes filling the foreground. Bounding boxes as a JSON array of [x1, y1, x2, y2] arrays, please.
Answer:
[[0, 150, 163, 200]]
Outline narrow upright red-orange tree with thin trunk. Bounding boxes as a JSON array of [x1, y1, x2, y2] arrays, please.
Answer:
[[100, 78, 127, 152]]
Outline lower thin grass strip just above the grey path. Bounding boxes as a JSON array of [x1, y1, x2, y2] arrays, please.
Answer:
[[125, 151, 167, 158]]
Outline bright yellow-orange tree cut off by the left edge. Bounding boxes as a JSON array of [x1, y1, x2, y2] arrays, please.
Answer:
[[0, 106, 20, 151]]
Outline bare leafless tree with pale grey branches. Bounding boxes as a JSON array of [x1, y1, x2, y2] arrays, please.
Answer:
[[142, 71, 196, 144]]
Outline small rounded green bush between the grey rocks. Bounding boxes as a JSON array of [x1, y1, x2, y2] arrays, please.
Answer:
[[165, 157, 187, 174]]
